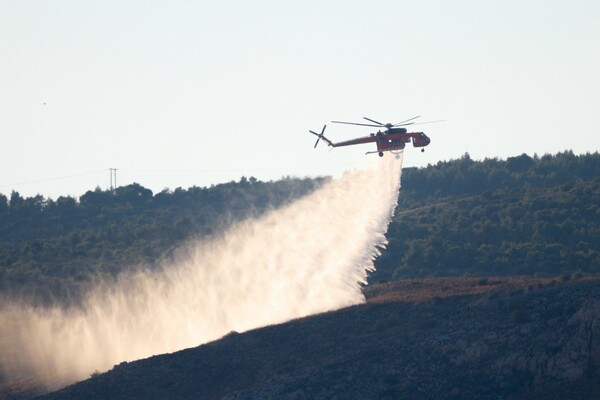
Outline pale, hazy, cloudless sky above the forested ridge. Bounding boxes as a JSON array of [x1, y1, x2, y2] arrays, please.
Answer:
[[0, 0, 600, 198]]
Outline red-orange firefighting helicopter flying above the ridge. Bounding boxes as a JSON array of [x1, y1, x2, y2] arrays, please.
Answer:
[[309, 116, 440, 157]]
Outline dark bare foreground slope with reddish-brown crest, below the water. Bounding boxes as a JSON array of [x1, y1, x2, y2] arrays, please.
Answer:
[[34, 278, 600, 400]]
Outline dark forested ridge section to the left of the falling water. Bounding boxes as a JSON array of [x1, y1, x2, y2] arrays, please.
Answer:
[[0, 177, 324, 303]]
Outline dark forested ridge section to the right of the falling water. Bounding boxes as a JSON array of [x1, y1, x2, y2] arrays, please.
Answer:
[[371, 152, 600, 281]]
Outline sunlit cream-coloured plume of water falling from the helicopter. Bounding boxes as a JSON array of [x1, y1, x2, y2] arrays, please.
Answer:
[[0, 154, 402, 388]]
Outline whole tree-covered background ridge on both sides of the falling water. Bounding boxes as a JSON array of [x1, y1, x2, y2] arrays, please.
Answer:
[[0, 152, 600, 303]]
